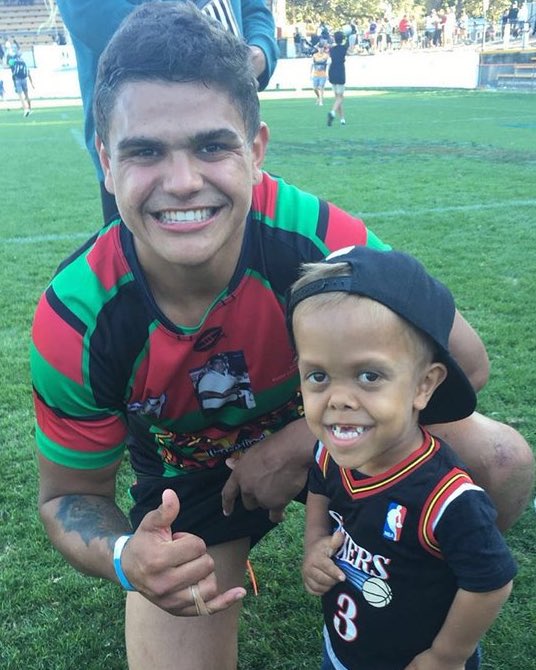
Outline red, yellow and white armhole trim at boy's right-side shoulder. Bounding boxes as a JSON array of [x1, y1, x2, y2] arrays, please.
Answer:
[[418, 468, 482, 558]]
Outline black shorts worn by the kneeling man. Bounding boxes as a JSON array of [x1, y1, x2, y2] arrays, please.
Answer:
[[130, 466, 303, 546]]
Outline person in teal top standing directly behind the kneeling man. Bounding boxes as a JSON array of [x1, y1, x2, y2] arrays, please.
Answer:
[[57, 0, 279, 223]]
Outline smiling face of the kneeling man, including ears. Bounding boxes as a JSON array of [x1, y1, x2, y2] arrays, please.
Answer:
[[97, 81, 267, 274]]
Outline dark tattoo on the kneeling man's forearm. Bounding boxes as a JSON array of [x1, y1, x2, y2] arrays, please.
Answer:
[[56, 495, 128, 547]]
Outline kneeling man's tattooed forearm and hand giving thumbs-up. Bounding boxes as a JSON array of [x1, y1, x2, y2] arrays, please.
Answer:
[[39, 455, 245, 616]]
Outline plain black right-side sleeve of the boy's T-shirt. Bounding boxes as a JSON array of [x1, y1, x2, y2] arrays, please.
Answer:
[[435, 487, 517, 593]]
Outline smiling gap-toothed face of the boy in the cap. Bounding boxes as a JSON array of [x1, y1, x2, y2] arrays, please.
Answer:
[[293, 296, 445, 475]]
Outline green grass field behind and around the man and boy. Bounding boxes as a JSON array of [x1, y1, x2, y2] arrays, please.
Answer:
[[0, 91, 536, 670]]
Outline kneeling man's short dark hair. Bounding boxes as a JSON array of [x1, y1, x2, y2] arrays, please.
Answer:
[[93, 1, 260, 145]]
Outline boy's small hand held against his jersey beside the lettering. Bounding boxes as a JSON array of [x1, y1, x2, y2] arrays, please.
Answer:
[[302, 532, 346, 596]]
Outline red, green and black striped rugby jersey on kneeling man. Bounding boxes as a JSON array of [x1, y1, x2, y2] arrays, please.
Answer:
[[31, 174, 388, 476]]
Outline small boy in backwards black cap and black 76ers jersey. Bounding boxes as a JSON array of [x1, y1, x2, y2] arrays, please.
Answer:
[[288, 247, 515, 670]]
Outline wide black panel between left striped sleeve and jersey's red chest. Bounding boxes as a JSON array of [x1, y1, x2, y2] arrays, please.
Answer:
[[89, 282, 153, 410]]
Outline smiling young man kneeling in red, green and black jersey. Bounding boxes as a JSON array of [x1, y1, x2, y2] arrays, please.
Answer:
[[31, 2, 530, 670]]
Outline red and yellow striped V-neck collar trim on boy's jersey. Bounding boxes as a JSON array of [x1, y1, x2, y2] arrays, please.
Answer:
[[339, 430, 439, 500]]
